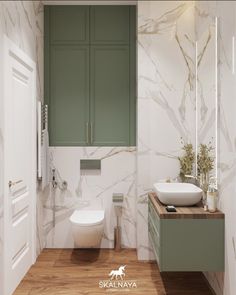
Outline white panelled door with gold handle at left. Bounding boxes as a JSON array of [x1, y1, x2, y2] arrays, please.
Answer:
[[3, 37, 36, 295]]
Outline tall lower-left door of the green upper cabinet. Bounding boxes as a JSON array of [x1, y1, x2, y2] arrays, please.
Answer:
[[49, 45, 89, 146]]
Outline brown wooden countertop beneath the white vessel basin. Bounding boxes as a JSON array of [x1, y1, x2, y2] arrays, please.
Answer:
[[149, 193, 225, 219]]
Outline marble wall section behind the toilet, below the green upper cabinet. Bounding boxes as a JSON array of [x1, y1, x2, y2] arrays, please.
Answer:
[[43, 147, 136, 248]]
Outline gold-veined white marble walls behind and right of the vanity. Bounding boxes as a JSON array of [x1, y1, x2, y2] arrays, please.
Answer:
[[137, 1, 236, 295]]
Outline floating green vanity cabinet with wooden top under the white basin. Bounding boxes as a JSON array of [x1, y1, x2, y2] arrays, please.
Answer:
[[148, 196, 224, 271]]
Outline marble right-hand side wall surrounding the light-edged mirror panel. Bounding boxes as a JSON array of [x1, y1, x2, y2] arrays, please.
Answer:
[[196, 1, 236, 295]]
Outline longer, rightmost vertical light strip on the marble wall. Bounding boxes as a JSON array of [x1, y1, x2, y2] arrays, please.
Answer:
[[215, 17, 219, 186]]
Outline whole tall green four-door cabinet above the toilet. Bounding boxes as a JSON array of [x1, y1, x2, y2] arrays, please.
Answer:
[[45, 5, 136, 146]]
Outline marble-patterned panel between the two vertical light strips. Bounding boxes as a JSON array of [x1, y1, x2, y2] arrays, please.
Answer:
[[196, 18, 217, 177]]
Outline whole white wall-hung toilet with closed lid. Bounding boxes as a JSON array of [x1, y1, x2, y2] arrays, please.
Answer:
[[70, 210, 105, 248]]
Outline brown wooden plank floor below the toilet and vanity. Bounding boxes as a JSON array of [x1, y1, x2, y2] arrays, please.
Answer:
[[14, 249, 212, 295]]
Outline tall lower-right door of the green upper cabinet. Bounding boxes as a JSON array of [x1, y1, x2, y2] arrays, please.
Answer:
[[90, 46, 130, 146]]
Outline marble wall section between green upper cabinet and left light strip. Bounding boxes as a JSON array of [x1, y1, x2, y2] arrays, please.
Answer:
[[137, 1, 196, 260]]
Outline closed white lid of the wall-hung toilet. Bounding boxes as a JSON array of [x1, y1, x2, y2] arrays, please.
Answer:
[[70, 210, 104, 226]]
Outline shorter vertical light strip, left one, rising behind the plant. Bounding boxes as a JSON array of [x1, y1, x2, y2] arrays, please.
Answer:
[[195, 42, 198, 176]]
